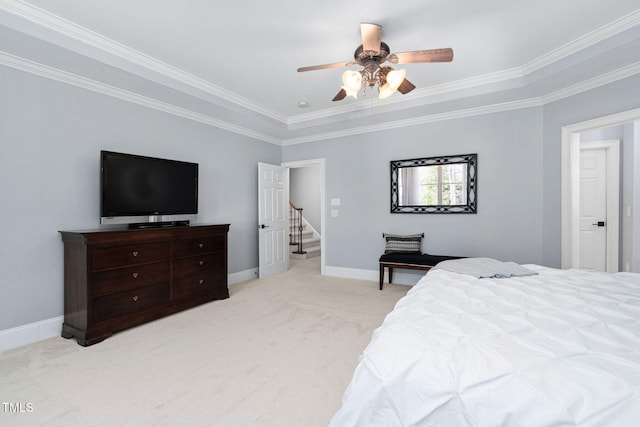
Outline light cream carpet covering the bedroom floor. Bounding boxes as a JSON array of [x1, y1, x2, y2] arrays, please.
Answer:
[[0, 258, 408, 427]]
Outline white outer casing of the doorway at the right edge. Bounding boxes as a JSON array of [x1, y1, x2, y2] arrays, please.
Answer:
[[561, 108, 640, 271]]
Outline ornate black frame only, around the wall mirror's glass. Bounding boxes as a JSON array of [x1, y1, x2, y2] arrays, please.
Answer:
[[391, 154, 478, 213]]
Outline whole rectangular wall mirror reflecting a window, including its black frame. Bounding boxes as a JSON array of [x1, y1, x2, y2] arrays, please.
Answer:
[[391, 154, 478, 213]]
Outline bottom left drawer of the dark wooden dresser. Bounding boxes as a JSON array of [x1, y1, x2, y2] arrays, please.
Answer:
[[92, 282, 169, 322]]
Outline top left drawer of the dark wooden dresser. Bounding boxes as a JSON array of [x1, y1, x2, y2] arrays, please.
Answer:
[[92, 242, 170, 271]]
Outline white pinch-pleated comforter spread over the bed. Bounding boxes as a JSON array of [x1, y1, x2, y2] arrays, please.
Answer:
[[331, 265, 640, 427]]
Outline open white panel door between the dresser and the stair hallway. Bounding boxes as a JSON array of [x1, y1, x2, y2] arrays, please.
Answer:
[[258, 163, 289, 277]]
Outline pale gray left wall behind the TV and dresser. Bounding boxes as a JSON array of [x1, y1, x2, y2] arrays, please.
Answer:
[[0, 67, 281, 331]]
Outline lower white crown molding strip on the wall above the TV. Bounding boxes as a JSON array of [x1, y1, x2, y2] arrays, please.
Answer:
[[0, 52, 281, 145]]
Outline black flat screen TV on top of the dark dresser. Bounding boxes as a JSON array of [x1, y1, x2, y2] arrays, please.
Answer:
[[100, 151, 198, 226]]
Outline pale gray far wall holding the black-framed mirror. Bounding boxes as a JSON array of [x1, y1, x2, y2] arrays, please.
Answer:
[[283, 107, 543, 271]]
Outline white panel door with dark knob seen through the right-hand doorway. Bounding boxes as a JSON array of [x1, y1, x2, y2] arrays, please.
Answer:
[[579, 148, 607, 271]]
